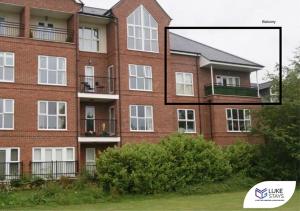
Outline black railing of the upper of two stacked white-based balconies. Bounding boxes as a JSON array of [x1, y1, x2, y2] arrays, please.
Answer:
[[80, 76, 116, 94]]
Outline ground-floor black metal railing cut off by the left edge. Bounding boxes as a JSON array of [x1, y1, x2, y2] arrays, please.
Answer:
[[0, 162, 23, 181]]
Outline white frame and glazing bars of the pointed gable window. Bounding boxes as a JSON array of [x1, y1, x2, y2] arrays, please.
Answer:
[[127, 5, 159, 53]]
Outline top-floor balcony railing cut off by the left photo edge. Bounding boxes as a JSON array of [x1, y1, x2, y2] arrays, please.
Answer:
[[0, 21, 24, 37]]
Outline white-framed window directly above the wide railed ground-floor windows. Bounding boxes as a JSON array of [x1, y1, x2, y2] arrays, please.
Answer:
[[38, 101, 67, 130]]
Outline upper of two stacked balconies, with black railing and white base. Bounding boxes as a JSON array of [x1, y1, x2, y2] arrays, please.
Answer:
[[78, 76, 119, 101]]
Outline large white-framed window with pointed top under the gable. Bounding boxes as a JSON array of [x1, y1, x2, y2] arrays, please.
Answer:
[[127, 5, 158, 53]]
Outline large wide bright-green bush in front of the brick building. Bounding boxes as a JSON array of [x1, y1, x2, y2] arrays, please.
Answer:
[[97, 135, 231, 194]]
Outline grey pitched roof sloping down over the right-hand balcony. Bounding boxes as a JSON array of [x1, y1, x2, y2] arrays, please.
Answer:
[[170, 33, 263, 68]]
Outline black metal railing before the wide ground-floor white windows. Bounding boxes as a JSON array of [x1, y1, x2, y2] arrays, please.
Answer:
[[30, 161, 78, 180]]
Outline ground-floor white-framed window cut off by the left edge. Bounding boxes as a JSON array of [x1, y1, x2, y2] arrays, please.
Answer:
[[0, 148, 20, 181]]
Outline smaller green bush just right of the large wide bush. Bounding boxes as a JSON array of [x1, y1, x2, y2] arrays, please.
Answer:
[[224, 141, 259, 175]]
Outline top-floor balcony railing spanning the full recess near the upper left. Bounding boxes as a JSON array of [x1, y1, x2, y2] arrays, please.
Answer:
[[30, 26, 73, 42]]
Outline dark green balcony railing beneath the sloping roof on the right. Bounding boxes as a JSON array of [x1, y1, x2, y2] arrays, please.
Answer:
[[205, 84, 258, 97]]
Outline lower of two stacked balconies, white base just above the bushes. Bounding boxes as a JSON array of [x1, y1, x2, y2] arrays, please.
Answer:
[[79, 119, 120, 143]]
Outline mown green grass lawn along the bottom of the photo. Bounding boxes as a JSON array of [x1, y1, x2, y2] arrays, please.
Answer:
[[11, 189, 300, 211]]
